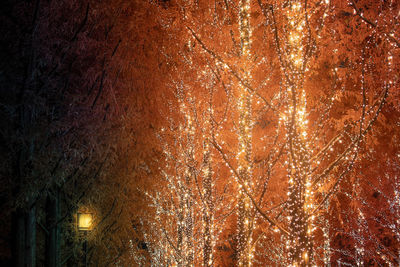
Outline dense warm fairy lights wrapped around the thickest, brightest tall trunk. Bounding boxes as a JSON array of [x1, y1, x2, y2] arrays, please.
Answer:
[[281, 2, 315, 266]]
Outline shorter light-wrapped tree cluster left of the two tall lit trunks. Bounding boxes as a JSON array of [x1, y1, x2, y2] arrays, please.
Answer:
[[142, 80, 229, 266]]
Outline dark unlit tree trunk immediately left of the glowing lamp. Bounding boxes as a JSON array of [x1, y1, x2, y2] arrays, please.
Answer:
[[46, 190, 60, 267]]
